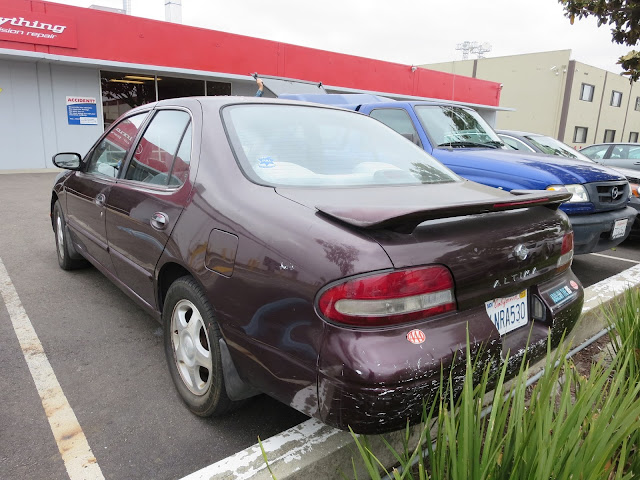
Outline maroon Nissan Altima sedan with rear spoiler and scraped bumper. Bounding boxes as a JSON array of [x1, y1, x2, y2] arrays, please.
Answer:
[[51, 97, 583, 433]]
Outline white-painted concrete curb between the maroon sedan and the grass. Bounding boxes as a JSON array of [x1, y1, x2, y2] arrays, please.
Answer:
[[182, 265, 640, 480]]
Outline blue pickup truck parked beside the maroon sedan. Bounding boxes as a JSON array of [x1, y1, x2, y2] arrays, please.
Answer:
[[280, 94, 637, 254]]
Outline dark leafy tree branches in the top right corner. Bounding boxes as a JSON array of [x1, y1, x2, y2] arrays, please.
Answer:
[[558, 0, 640, 82]]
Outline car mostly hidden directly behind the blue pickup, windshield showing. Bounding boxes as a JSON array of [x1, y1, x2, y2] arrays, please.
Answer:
[[496, 130, 640, 237]]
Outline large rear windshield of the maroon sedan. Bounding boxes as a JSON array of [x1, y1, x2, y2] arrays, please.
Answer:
[[223, 104, 461, 187]]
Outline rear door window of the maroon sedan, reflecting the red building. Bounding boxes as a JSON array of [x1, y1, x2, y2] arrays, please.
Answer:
[[124, 110, 191, 185]]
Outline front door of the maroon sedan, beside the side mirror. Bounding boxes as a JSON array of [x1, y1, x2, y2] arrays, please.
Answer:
[[65, 112, 147, 273]]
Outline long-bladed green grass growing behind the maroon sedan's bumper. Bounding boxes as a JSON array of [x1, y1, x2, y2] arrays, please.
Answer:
[[353, 290, 640, 480]]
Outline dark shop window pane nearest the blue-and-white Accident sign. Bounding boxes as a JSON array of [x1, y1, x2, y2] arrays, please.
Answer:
[[100, 71, 156, 128]]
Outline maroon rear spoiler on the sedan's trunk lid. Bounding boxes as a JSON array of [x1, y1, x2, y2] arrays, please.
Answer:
[[316, 190, 572, 233]]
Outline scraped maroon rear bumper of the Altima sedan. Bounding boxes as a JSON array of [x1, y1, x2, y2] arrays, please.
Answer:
[[318, 270, 584, 434]]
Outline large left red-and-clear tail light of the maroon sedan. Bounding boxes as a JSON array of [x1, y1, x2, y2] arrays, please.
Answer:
[[318, 265, 456, 327]]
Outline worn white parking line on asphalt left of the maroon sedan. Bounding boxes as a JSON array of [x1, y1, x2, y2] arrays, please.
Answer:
[[0, 258, 104, 480]]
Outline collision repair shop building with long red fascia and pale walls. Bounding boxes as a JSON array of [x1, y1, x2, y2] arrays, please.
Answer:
[[0, 0, 500, 170]]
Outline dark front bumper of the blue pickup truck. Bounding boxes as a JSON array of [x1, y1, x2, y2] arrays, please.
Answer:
[[569, 207, 638, 255]]
